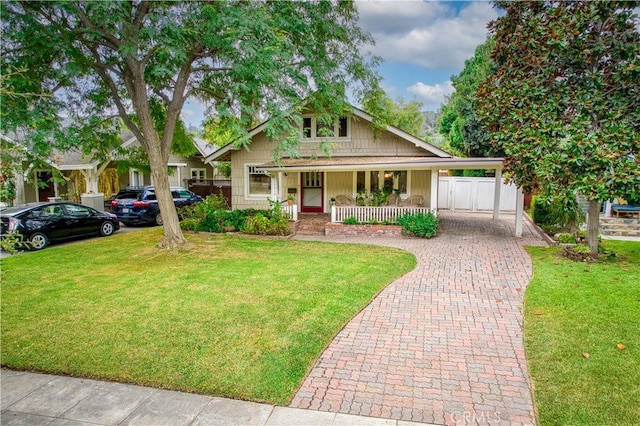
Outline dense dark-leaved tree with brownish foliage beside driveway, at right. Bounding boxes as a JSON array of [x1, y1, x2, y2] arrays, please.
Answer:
[[478, 1, 640, 256]]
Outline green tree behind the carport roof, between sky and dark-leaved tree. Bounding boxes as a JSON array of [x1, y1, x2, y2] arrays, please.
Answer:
[[438, 38, 503, 157]]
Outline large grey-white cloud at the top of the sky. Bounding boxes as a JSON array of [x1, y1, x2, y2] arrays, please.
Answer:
[[357, 1, 498, 69]]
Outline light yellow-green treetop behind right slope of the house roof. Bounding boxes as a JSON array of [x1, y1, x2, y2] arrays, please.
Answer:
[[363, 88, 424, 136]]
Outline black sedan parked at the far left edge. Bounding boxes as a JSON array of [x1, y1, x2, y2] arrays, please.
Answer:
[[0, 202, 120, 250]]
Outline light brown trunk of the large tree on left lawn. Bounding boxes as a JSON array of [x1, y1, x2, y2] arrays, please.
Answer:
[[148, 148, 187, 249]]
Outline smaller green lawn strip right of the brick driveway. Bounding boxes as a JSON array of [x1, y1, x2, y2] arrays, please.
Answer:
[[525, 241, 640, 425]]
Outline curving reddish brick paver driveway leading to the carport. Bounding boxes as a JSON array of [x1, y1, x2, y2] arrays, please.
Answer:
[[291, 212, 545, 424]]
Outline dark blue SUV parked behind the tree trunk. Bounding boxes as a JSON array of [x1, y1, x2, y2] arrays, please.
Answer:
[[111, 186, 202, 226]]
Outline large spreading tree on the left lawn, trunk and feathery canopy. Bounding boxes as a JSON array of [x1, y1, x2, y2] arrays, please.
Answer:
[[2, 0, 377, 248]]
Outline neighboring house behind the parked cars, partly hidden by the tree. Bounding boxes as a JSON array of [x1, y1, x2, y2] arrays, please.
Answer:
[[2, 134, 228, 209]]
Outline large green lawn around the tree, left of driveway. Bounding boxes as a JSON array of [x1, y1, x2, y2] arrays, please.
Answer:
[[1, 228, 416, 404]]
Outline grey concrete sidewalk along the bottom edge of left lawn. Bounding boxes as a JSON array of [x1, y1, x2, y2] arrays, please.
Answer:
[[0, 370, 432, 426]]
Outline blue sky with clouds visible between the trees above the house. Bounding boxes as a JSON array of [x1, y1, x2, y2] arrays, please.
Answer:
[[182, 0, 498, 126]]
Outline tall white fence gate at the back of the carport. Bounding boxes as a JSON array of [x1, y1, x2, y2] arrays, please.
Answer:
[[438, 176, 518, 212]]
